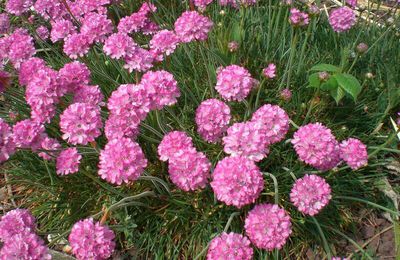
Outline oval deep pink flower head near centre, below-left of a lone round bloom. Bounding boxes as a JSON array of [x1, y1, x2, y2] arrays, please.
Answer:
[[196, 99, 231, 143]]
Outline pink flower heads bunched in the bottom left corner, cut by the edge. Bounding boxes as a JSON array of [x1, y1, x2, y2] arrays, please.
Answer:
[[0, 209, 51, 260]]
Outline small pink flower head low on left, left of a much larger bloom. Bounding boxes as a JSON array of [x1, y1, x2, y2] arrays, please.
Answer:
[[56, 147, 82, 175]]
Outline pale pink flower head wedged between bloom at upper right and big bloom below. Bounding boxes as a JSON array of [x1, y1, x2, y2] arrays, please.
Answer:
[[222, 121, 269, 162]]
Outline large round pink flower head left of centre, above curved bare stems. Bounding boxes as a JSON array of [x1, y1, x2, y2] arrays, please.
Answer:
[[99, 138, 147, 185]]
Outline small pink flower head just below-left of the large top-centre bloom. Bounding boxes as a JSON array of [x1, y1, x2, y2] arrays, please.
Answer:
[[150, 30, 179, 56]]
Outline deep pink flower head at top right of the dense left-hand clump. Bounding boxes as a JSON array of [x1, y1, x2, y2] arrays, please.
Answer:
[[58, 61, 90, 92]]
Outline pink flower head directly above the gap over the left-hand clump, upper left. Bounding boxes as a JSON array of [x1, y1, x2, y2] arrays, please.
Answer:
[[64, 33, 92, 59]]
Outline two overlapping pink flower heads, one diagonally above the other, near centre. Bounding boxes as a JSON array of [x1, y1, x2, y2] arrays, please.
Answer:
[[158, 131, 211, 191]]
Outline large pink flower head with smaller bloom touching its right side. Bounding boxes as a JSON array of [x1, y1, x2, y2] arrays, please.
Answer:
[[292, 123, 340, 171]]
